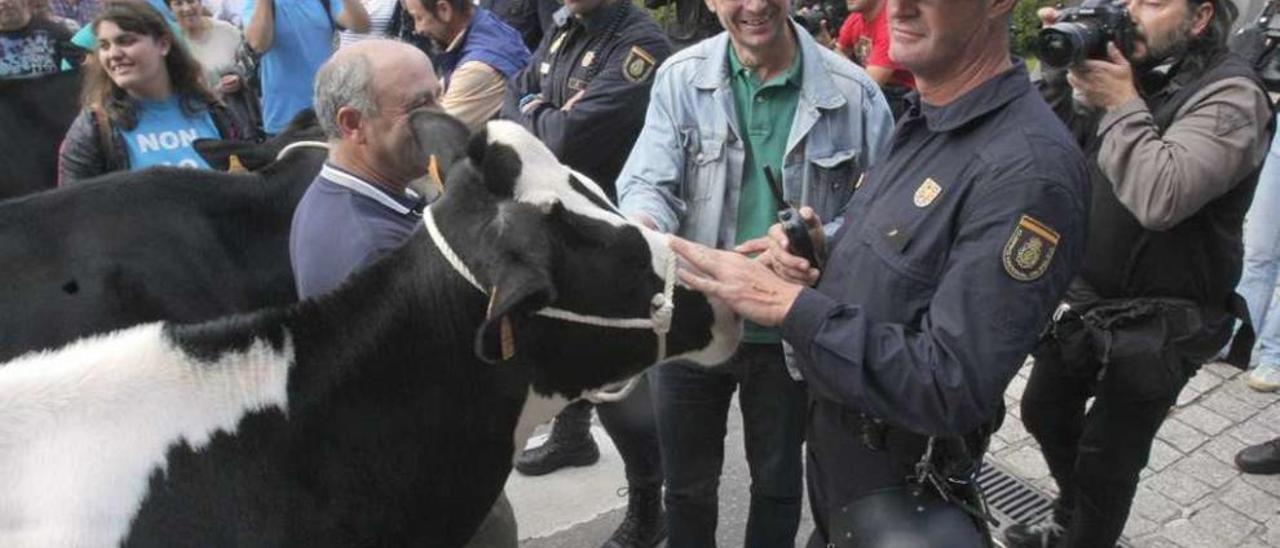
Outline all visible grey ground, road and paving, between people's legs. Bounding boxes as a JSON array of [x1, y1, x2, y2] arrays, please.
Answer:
[[507, 364, 1280, 548]]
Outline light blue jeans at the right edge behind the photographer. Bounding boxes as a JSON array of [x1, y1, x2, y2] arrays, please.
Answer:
[[1235, 117, 1280, 364]]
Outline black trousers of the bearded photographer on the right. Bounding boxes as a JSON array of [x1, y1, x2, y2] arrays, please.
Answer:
[[1021, 343, 1193, 548]]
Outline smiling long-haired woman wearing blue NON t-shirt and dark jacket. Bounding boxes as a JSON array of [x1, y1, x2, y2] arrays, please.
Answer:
[[58, 3, 241, 184]]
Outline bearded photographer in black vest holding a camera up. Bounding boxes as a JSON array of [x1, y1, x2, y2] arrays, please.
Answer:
[[1006, 0, 1271, 548]]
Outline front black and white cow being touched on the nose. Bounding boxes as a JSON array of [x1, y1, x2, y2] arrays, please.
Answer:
[[0, 122, 739, 547]]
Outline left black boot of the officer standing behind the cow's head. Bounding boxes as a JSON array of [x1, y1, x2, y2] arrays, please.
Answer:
[[516, 402, 600, 476]]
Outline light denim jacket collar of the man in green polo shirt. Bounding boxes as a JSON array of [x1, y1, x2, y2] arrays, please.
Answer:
[[694, 20, 846, 109]]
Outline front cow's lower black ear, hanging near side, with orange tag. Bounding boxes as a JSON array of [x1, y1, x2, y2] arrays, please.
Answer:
[[475, 256, 556, 364]]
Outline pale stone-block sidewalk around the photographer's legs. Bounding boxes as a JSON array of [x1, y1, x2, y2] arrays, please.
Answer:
[[991, 364, 1280, 548]]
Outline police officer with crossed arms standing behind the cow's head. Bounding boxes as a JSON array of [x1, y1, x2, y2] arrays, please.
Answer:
[[502, 0, 671, 548]]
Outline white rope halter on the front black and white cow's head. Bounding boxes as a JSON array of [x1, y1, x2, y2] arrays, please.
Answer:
[[422, 207, 676, 403]]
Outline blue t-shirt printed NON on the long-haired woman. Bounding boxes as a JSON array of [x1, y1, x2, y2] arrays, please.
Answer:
[[120, 95, 221, 169]]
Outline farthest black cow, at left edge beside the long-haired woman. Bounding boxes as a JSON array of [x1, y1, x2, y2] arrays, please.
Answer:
[[0, 70, 81, 200]]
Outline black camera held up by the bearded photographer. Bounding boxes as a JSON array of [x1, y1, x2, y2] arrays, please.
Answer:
[[1036, 0, 1135, 68]]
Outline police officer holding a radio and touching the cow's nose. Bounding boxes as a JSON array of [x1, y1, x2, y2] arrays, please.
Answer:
[[673, 0, 1088, 547]]
